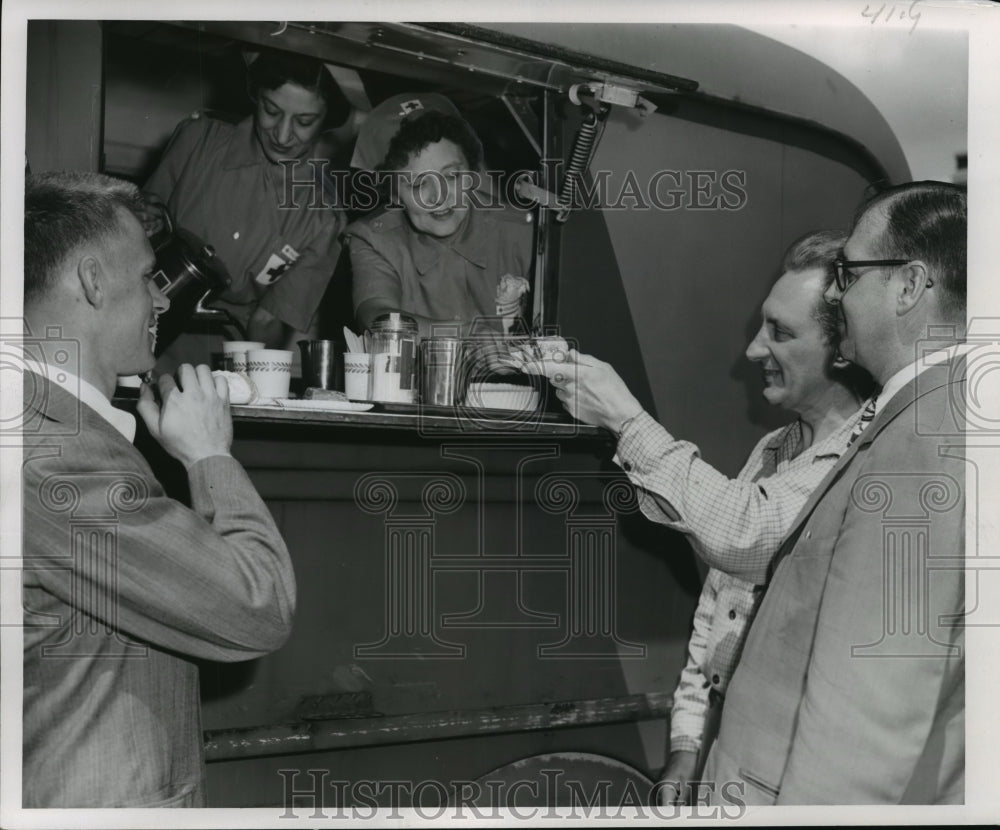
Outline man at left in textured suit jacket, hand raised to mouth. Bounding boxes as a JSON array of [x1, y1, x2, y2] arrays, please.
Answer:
[[22, 173, 295, 807]]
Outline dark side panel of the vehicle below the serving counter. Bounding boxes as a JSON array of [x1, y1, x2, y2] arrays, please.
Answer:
[[133, 406, 698, 806]]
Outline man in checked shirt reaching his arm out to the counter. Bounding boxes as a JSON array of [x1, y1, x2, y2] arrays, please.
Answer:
[[525, 231, 871, 803]]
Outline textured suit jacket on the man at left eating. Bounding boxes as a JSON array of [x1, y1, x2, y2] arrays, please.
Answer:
[[22, 375, 295, 807]]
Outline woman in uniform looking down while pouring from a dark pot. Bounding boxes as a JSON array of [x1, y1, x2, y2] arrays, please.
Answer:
[[142, 50, 351, 369]]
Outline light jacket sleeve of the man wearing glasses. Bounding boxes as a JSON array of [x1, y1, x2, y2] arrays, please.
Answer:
[[778, 436, 965, 804]]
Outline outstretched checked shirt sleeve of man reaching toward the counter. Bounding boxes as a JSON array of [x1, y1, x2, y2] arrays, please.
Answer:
[[615, 412, 835, 584]]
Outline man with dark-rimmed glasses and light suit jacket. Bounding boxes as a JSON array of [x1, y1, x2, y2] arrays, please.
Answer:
[[705, 182, 966, 804]]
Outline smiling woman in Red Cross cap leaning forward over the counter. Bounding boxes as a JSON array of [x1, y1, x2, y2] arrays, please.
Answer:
[[345, 93, 534, 337]]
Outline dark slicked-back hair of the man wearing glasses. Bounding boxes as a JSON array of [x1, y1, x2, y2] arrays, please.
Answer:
[[854, 181, 968, 317]]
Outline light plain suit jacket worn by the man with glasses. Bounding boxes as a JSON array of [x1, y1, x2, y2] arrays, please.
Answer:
[[704, 361, 966, 804]]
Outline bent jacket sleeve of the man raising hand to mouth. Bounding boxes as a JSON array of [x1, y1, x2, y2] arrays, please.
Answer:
[[24, 434, 295, 661]]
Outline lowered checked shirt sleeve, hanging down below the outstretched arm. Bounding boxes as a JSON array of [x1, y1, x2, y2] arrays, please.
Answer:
[[670, 570, 719, 752]]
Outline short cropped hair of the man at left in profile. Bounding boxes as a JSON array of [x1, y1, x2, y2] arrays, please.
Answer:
[[24, 171, 142, 305]]
